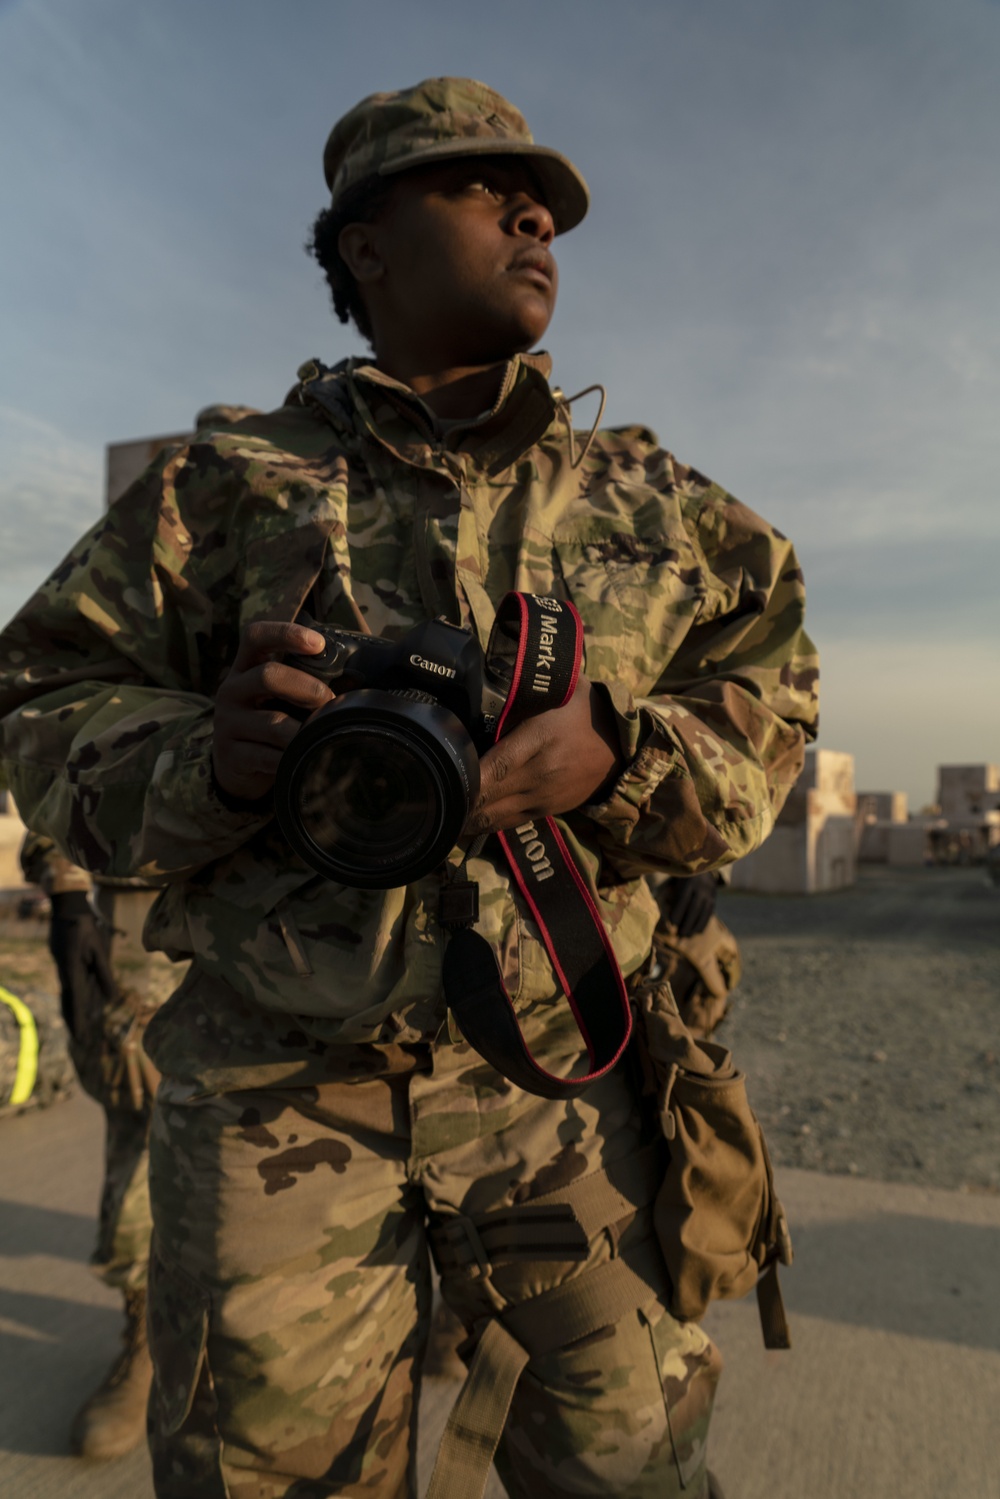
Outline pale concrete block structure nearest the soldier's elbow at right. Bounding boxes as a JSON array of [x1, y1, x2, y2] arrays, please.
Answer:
[[732, 750, 858, 895]]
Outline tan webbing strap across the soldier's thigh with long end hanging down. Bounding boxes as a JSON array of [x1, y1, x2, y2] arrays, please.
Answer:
[[427, 1246, 663, 1499]]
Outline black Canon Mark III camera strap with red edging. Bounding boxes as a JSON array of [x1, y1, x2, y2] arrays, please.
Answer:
[[439, 594, 631, 1099]]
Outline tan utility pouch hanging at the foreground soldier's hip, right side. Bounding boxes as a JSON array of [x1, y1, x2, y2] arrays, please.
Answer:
[[634, 979, 792, 1348]]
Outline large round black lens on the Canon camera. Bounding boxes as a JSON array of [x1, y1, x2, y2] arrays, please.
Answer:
[[274, 688, 480, 890]]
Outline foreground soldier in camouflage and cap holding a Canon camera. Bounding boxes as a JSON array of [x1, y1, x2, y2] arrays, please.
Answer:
[[0, 78, 816, 1499]]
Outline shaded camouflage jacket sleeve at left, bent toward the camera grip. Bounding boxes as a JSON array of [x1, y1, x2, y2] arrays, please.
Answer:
[[0, 444, 274, 883]]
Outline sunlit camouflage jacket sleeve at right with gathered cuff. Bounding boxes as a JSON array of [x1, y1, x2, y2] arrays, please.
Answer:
[[585, 463, 819, 877]]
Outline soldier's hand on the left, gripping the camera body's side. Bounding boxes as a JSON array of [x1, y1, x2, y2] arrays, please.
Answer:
[[211, 621, 333, 802]]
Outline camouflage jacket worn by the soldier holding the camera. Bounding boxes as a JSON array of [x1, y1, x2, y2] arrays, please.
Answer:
[[0, 355, 817, 1042]]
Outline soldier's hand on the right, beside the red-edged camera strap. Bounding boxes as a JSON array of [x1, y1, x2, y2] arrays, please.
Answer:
[[465, 676, 624, 835]]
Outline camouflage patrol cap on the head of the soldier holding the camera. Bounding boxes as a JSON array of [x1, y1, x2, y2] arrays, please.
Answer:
[[322, 78, 591, 234]]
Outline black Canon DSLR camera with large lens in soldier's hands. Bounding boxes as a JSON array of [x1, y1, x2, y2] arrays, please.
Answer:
[[274, 616, 507, 890]]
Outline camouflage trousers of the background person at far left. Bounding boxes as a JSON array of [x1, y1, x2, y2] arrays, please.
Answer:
[[76, 887, 186, 1291]]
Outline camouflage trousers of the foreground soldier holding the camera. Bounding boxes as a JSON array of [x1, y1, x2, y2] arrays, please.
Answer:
[[148, 971, 721, 1499]]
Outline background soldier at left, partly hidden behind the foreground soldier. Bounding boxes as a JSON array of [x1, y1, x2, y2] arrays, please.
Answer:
[[21, 832, 187, 1459]]
